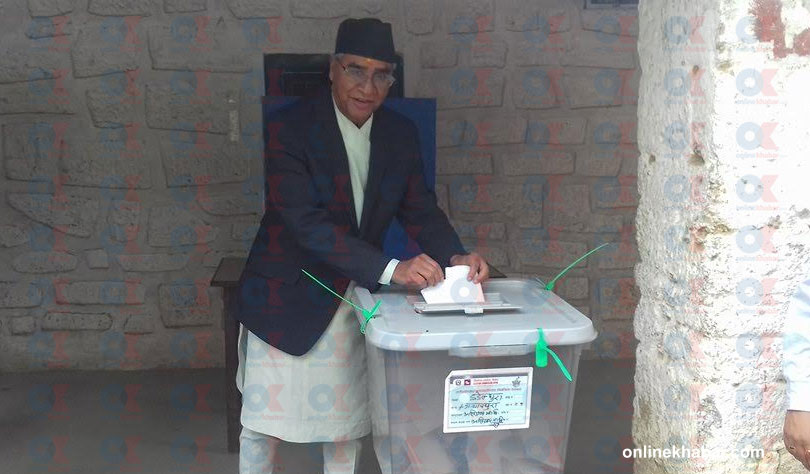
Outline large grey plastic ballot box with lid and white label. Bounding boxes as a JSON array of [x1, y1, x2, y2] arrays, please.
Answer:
[[353, 279, 596, 474]]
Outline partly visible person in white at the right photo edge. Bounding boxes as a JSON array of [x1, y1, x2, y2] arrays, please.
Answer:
[[782, 274, 810, 471]]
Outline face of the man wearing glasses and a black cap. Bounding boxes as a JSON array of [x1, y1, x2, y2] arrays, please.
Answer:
[[329, 54, 393, 127]]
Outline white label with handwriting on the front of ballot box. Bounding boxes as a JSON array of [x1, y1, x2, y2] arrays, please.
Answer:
[[444, 367, 533, 433]]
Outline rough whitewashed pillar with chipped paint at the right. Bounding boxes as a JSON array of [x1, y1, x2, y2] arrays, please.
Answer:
[[633, 0, 810, 474]]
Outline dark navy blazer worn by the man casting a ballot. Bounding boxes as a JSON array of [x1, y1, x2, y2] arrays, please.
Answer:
[[238, 89, 467, 356]]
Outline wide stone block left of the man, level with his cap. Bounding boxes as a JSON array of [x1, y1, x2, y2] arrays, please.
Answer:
[[149, 23, 253, 72]]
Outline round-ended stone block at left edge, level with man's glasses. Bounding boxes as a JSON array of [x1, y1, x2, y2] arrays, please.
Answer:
[[0, 45, 70, 84]]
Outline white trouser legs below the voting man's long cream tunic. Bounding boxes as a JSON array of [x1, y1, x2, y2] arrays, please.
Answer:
[[239, 427, 362, 474]]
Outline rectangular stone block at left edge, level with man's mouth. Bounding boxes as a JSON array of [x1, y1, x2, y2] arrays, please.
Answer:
[[0, 77, 77, 115]]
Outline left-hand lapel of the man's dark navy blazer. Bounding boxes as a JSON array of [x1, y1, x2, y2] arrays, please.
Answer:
[[315, 89, 356, 233]]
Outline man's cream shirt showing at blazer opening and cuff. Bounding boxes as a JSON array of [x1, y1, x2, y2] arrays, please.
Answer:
[[332, 96, 399, 285]]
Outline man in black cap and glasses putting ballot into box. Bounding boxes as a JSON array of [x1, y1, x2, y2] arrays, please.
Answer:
[[237, 18, 489, 473]]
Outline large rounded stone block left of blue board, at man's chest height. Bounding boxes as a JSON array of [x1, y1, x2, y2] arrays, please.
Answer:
[[160, 132, 250, 188]]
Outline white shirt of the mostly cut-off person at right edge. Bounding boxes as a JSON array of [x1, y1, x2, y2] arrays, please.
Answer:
[[782, 279, 810, 411]]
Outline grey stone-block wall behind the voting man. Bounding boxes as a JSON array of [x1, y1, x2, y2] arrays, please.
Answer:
[[0, 0, 638, 369]]
